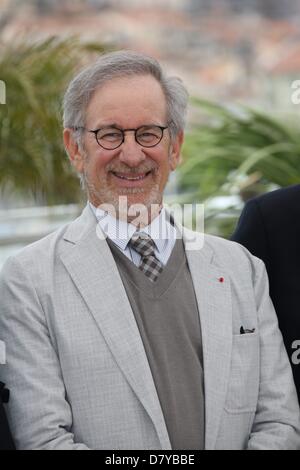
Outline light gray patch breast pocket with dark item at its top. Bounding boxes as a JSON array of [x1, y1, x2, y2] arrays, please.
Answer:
[[225, 333, 260, 413]]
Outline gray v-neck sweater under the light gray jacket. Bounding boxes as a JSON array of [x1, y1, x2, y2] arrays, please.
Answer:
[[107, 239, 205, 450]]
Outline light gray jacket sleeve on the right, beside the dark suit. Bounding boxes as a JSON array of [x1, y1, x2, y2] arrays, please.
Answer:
[[248, 259, 300, 450]]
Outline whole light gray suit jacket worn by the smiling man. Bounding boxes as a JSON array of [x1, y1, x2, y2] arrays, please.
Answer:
[[0, 206, 300, 449]]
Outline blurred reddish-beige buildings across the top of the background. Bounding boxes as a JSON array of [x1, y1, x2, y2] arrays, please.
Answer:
[[0, 0, 300, 111]]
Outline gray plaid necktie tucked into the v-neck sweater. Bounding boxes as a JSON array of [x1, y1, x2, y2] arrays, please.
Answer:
[[129, 233, 163, 282]]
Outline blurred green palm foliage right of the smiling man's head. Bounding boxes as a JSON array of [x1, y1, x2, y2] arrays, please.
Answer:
[[179, 99, 300, 235]]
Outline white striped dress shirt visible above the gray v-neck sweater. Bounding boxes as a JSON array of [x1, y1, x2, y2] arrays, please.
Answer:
[[89, 202, 177, 266]]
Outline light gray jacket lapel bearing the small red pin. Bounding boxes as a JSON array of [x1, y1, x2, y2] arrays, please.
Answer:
[[184, 229, 232, 449]]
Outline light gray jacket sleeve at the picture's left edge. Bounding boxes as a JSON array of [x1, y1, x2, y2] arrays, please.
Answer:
[[0, 259, 87, 450]]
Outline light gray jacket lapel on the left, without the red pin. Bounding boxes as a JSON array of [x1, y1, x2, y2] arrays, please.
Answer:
[[61, 207, 171, 449]]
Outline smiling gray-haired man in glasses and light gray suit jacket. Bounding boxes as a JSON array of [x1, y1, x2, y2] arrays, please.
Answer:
[[0, 51, 300, 450]]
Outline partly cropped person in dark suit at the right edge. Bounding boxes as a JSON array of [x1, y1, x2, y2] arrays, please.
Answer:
[[233, 185, 300, 403]]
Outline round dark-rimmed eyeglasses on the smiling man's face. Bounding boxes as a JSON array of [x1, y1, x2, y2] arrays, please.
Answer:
[[75, 125, 168, 150]]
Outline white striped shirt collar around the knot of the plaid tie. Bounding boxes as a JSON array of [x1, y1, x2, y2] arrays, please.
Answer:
[[89, 202, 176, 252]]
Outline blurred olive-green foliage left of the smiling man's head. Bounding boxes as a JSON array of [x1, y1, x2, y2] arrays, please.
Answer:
[[0, 38, 110, 205]]
